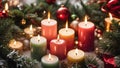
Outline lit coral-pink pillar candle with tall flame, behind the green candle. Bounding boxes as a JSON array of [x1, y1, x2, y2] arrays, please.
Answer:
[[41, 13, 57, 49]]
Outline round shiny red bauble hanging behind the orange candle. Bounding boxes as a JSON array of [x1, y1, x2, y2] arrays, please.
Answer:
[[56, 6, 70, 21]]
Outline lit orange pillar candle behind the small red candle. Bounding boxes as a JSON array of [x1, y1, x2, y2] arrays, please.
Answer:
[[59, 22, 75, 51]]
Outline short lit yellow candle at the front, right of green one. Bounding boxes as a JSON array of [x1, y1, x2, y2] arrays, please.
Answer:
[[67, 48, 85, 63]]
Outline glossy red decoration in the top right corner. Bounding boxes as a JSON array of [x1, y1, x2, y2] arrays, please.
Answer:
[[101, 0, 120, 18]]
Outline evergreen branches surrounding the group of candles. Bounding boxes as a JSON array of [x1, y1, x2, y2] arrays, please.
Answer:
[[0, 0, 120, 68]]
